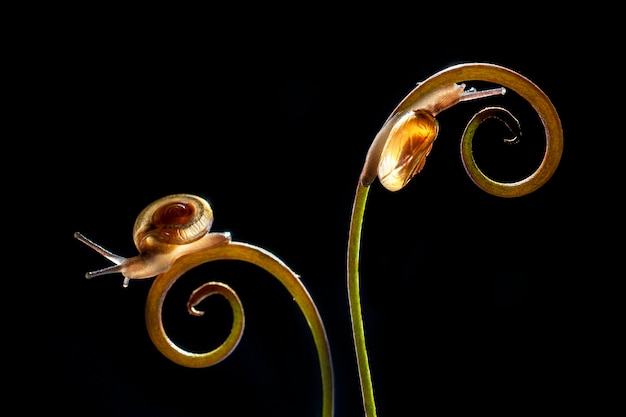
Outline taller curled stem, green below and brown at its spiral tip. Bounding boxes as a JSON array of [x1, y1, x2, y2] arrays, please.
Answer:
[[347, 63, 563, 417]]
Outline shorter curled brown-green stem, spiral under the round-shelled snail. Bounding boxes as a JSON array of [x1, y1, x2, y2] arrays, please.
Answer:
[[145, 242, 334, 417]]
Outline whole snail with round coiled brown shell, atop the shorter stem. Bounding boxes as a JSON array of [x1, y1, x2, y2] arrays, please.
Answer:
[[74, 194, 230, 287]]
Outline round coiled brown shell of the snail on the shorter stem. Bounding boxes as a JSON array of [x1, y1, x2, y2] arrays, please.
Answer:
[[133, 194, 213, 252]]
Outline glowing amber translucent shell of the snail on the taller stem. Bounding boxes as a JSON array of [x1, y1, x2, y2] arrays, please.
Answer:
[[378, 109, 439, 191]]
